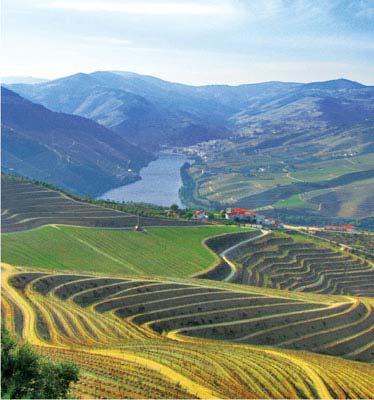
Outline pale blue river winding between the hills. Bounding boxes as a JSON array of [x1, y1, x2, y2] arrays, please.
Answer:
[[100, 155, 191, 207]]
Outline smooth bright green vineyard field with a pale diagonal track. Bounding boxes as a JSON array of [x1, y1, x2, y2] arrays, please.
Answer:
[[2, 225, 250, 277]]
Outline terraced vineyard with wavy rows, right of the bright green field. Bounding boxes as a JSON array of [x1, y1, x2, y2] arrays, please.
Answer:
[[219, 232, 374, 297]]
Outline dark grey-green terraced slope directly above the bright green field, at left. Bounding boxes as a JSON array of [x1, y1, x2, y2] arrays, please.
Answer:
[[1, 175, 200, 232]]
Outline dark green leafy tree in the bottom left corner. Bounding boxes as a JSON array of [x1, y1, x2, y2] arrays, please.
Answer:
[[1, 325, 79, 399]]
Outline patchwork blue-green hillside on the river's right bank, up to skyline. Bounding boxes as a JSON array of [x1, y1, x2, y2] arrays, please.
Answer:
[[179, 79, 374, 224]]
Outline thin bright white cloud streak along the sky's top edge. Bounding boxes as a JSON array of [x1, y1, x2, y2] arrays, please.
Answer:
[[41, 0, 233, 15]]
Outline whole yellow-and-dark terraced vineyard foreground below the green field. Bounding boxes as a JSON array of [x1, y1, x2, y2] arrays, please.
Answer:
[[2, 265, 373, 398]]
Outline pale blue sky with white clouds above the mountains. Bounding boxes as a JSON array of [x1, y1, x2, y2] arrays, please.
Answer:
[[1, 0, 374, 85]]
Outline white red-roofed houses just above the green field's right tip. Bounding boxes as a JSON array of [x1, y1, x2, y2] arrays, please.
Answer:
[[193, 207, 283, 229]]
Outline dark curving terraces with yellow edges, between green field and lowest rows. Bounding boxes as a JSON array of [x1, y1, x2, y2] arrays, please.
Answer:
[[10, 273, 374, 362]]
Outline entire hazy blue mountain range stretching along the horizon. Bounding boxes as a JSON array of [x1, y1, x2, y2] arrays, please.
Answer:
[[6, 71, 374, 145]]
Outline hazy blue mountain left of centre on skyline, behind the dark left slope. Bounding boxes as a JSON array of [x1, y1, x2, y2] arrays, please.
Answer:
[[9, 72, 228, 150]]
